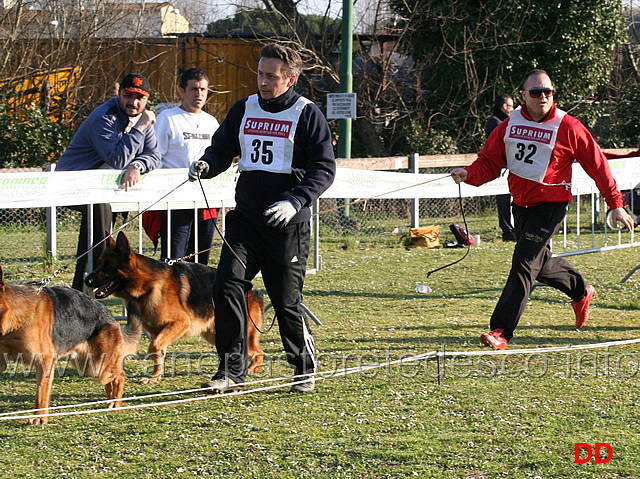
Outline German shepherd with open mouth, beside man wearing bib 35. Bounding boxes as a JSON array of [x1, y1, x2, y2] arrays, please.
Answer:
[[85, 232, 264, 384]]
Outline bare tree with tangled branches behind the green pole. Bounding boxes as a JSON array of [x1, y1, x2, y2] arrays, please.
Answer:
[[208, 0, 420, 156]]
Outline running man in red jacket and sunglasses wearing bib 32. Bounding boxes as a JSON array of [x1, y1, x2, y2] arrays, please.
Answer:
[[451, 70, 633, 349]]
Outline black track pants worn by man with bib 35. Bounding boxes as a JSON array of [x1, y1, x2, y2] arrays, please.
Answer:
[[214, 211, 315, 382]]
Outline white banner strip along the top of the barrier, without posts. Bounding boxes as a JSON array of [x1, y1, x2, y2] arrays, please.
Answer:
[[0, 158, 640, 209]]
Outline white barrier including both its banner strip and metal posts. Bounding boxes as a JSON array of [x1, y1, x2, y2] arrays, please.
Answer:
[[0, 158, 640, 278]]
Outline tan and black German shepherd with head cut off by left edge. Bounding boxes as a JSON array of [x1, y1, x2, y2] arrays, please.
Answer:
[[0, 267, 142, 424]]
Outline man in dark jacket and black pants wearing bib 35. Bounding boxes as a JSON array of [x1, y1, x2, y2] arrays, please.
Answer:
[[189, 44, 336, 393]]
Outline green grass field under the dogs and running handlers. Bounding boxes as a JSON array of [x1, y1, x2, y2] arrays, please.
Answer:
[[0, 230, 640, 479]]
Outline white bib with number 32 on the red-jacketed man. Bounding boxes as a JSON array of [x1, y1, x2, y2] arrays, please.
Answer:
[[504, 108, 566, 183]]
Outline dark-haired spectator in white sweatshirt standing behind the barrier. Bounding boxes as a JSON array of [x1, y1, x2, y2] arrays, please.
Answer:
[[154, 68, 220, 264]]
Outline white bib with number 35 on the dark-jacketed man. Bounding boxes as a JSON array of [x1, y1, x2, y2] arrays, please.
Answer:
[[238, 95, 311, 174]]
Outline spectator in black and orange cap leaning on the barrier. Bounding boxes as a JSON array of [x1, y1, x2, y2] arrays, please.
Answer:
[[56, 73, 160, 291]]
